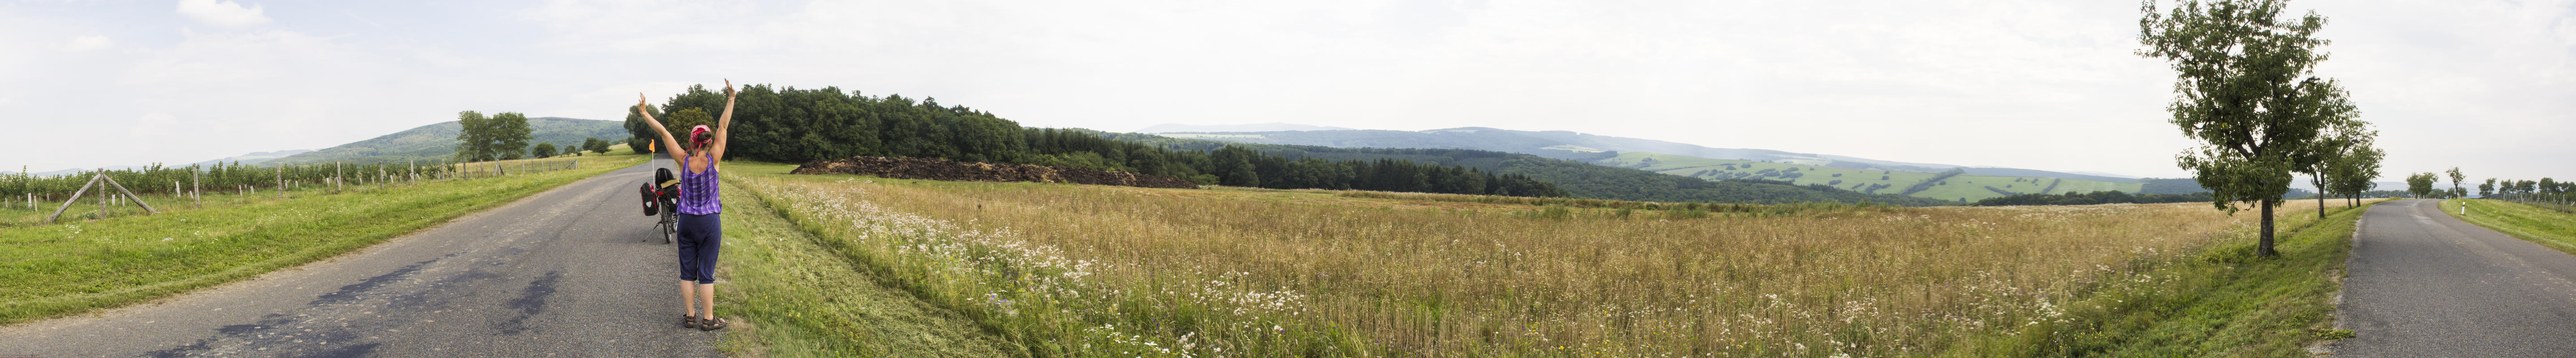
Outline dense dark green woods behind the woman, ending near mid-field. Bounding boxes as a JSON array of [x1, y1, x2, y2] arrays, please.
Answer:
[[626, 85, 1566, 196]]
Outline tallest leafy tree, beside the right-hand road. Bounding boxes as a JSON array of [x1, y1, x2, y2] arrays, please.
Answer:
[[2138, 0, 2360, 255]]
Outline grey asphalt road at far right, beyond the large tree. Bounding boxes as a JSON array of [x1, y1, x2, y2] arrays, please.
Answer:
[[2329, 201, 2576, 358]]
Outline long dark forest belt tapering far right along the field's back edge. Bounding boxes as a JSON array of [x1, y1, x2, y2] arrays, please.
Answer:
[[626, 85, 1953, 206]]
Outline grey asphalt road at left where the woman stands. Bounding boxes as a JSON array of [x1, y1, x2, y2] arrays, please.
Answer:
[[0, 160, 724, 358]]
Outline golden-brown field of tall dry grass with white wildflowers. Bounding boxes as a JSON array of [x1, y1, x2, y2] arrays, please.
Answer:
[[737, 165, 2370, 355]]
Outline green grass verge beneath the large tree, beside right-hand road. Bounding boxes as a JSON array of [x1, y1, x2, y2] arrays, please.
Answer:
[[1999, 201, 2380, 358]]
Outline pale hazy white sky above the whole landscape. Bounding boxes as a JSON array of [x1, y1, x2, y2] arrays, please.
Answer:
[[0, 0, 2576, 180]]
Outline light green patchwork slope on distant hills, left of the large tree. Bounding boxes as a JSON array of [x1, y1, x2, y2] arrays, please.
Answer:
[[1592, 152, 2143, 201]]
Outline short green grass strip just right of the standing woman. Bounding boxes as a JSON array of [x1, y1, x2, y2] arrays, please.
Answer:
[[716, 178, 1020, 358]]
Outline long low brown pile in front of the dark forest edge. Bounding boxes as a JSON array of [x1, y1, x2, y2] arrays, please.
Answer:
[[793, 157, 1198, 188]]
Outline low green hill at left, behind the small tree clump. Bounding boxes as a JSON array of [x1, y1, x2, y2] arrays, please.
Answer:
[[271, 116, 626, 165]]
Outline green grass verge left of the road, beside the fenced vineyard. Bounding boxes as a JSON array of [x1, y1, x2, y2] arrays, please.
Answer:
[[0, 154, 644, 324]]
